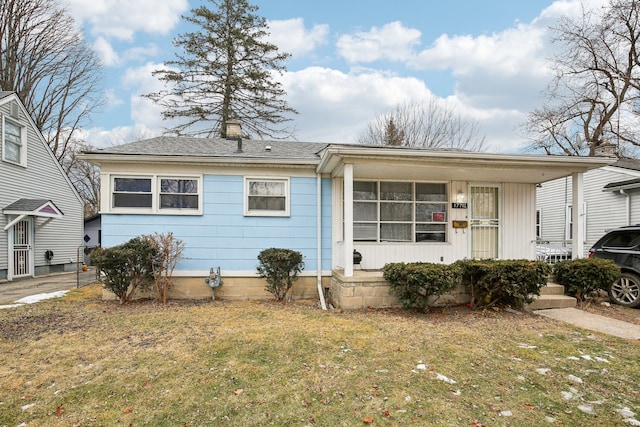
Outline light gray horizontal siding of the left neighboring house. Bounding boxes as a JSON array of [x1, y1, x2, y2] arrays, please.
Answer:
[[0, 96, 83, 278]]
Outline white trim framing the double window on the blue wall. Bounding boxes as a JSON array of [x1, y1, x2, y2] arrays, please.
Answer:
[[108, 174, 204, 216]]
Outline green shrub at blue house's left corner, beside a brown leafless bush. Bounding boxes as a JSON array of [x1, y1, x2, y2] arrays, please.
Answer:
[[89, 237, 154, 304]]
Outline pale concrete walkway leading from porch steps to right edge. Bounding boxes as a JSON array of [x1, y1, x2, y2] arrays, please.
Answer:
[[534, 308, 640, 340]]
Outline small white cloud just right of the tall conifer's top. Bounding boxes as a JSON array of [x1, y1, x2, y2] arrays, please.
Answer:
[[268, 18, 329, 56]]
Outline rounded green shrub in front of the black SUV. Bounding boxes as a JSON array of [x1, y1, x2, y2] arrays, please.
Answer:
[[553, 258, 621, 301]]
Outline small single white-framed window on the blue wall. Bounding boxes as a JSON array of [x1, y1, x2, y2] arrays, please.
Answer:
[[244, 178, 289, 216]]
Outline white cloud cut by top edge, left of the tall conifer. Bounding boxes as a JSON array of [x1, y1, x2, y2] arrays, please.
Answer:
[[66, 0, 189, 40]]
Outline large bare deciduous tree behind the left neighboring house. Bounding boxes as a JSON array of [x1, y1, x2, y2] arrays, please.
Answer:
[[0, 0, 103, 160]]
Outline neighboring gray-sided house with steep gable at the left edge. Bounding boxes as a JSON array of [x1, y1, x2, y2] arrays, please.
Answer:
[[0, 91, 83, 286]]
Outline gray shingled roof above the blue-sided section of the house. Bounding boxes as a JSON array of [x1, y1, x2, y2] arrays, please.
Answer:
[[90, 136, 328, 160]]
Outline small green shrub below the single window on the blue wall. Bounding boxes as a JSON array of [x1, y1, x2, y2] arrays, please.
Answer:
[[258, 248, 304, 301]]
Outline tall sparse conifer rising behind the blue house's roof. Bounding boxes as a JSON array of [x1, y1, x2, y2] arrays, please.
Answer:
[[146, 0, 296, 138]]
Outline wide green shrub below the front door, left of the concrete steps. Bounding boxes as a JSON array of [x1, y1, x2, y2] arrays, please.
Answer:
[[455, 260, 551, 308]]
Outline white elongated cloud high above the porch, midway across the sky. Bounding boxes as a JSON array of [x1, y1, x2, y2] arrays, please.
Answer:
[[337, 21, 421, 63]]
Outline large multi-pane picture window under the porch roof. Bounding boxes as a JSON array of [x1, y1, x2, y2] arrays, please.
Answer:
[[353, 181, 447, 242]]
